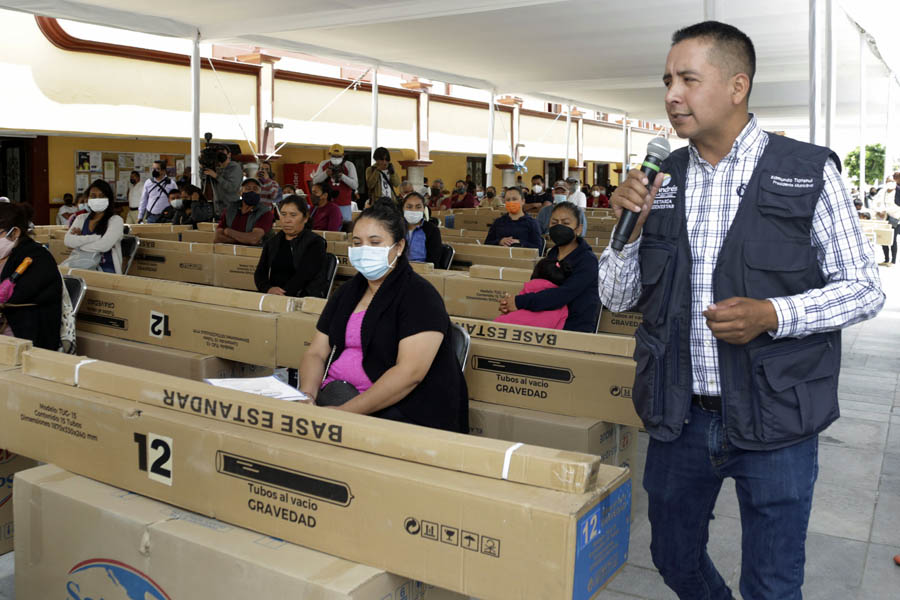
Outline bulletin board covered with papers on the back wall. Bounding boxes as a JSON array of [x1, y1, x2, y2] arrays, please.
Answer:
[[75, 150, 187, 201]]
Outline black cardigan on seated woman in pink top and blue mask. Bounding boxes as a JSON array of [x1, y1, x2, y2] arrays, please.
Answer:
[[316, 257, 469, 433]]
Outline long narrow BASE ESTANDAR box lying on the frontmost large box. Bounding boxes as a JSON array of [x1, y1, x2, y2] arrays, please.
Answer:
[[23, 350, 600, 493]]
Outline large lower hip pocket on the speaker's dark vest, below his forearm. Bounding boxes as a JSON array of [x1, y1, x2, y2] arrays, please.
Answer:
[[751, 336, 839, 442]]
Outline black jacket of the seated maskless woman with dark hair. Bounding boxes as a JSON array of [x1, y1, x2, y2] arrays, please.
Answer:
[[253, 229, 328, 298]]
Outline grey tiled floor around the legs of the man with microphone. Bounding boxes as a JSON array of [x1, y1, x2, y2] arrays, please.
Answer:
[[600, 266, 900, 600]]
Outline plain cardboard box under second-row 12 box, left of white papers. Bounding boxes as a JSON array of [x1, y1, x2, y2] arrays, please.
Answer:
[[78, 332, 272, 381]]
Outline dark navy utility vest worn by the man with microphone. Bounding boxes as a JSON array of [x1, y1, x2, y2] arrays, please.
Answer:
[[633, 135, 841, 450]]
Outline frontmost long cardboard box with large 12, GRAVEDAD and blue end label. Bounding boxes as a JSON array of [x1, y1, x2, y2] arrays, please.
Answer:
[[0, 375, 631, 600]]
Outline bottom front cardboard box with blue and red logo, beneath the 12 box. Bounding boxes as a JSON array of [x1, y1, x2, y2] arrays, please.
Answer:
[[16, 465, 459, 600]]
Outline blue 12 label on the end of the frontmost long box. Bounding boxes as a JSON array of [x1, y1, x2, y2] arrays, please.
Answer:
[[572, 480, 631, 600]]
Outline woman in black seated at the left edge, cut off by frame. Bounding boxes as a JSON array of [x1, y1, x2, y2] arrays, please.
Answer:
[[0, 203, 62, 351]]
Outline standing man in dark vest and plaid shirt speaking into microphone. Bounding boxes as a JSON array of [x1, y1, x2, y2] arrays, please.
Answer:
[[599, 21, 884, 600]]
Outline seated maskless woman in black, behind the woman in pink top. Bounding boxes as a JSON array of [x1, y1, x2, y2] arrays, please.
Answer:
[[253, 196, 328, 298]]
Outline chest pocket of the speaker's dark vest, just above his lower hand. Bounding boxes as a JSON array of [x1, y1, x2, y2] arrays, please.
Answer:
[[744, 240, 818, 300]]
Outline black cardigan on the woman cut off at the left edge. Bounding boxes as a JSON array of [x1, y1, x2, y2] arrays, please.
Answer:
[[0, 237, 62, 351]]
